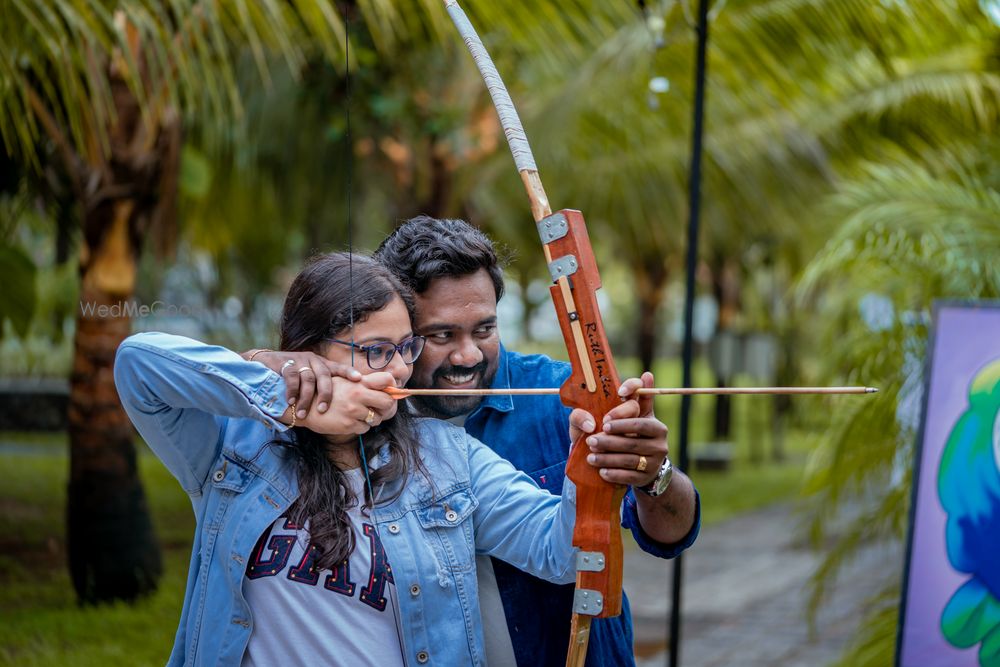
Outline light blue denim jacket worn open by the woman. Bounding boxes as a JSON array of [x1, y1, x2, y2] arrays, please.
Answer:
[[115, 333, 576, 665]]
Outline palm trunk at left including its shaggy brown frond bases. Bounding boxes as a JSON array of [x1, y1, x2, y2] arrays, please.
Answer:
[[29, 12, 181, 604]]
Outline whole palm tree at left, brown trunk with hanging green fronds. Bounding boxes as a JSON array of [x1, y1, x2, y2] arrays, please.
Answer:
[[0, 0, 360, 602]]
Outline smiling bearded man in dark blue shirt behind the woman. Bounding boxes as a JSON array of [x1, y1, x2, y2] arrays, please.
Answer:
[[375, 217, 700, 667]]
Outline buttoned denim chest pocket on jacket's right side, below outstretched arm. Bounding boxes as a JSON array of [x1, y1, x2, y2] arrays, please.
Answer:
[[416, 488, 479, 573]]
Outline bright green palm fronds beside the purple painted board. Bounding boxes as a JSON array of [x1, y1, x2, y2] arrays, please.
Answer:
[[801, 145, 1000, 664]]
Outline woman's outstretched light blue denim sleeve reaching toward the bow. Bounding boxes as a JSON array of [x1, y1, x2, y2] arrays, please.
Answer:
[[468, 436, 576, 583]]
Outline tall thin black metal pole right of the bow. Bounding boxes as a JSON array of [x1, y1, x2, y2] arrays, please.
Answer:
[[669, 0, 708, 667]]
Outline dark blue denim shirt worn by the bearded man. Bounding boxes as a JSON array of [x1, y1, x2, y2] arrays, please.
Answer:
[[465, 347, 701, 667]]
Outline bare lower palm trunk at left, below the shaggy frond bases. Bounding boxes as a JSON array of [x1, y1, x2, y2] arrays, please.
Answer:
[[66, 200, 162, 604]]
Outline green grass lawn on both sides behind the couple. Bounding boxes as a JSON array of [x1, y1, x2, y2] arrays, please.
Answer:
[[0, 368, 828, 667]]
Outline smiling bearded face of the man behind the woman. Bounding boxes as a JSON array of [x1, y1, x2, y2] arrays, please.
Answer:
[[408, 269, 500, 418]]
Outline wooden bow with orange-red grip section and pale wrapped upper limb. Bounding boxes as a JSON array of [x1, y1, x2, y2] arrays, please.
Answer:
[[444, 0, 625, 666]]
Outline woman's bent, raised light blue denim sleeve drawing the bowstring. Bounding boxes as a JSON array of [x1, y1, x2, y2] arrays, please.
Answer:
[[115, 333, 288, 494]]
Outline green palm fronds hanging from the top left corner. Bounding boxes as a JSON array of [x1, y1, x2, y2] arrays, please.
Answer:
[[0, 0, 345, 167]]
